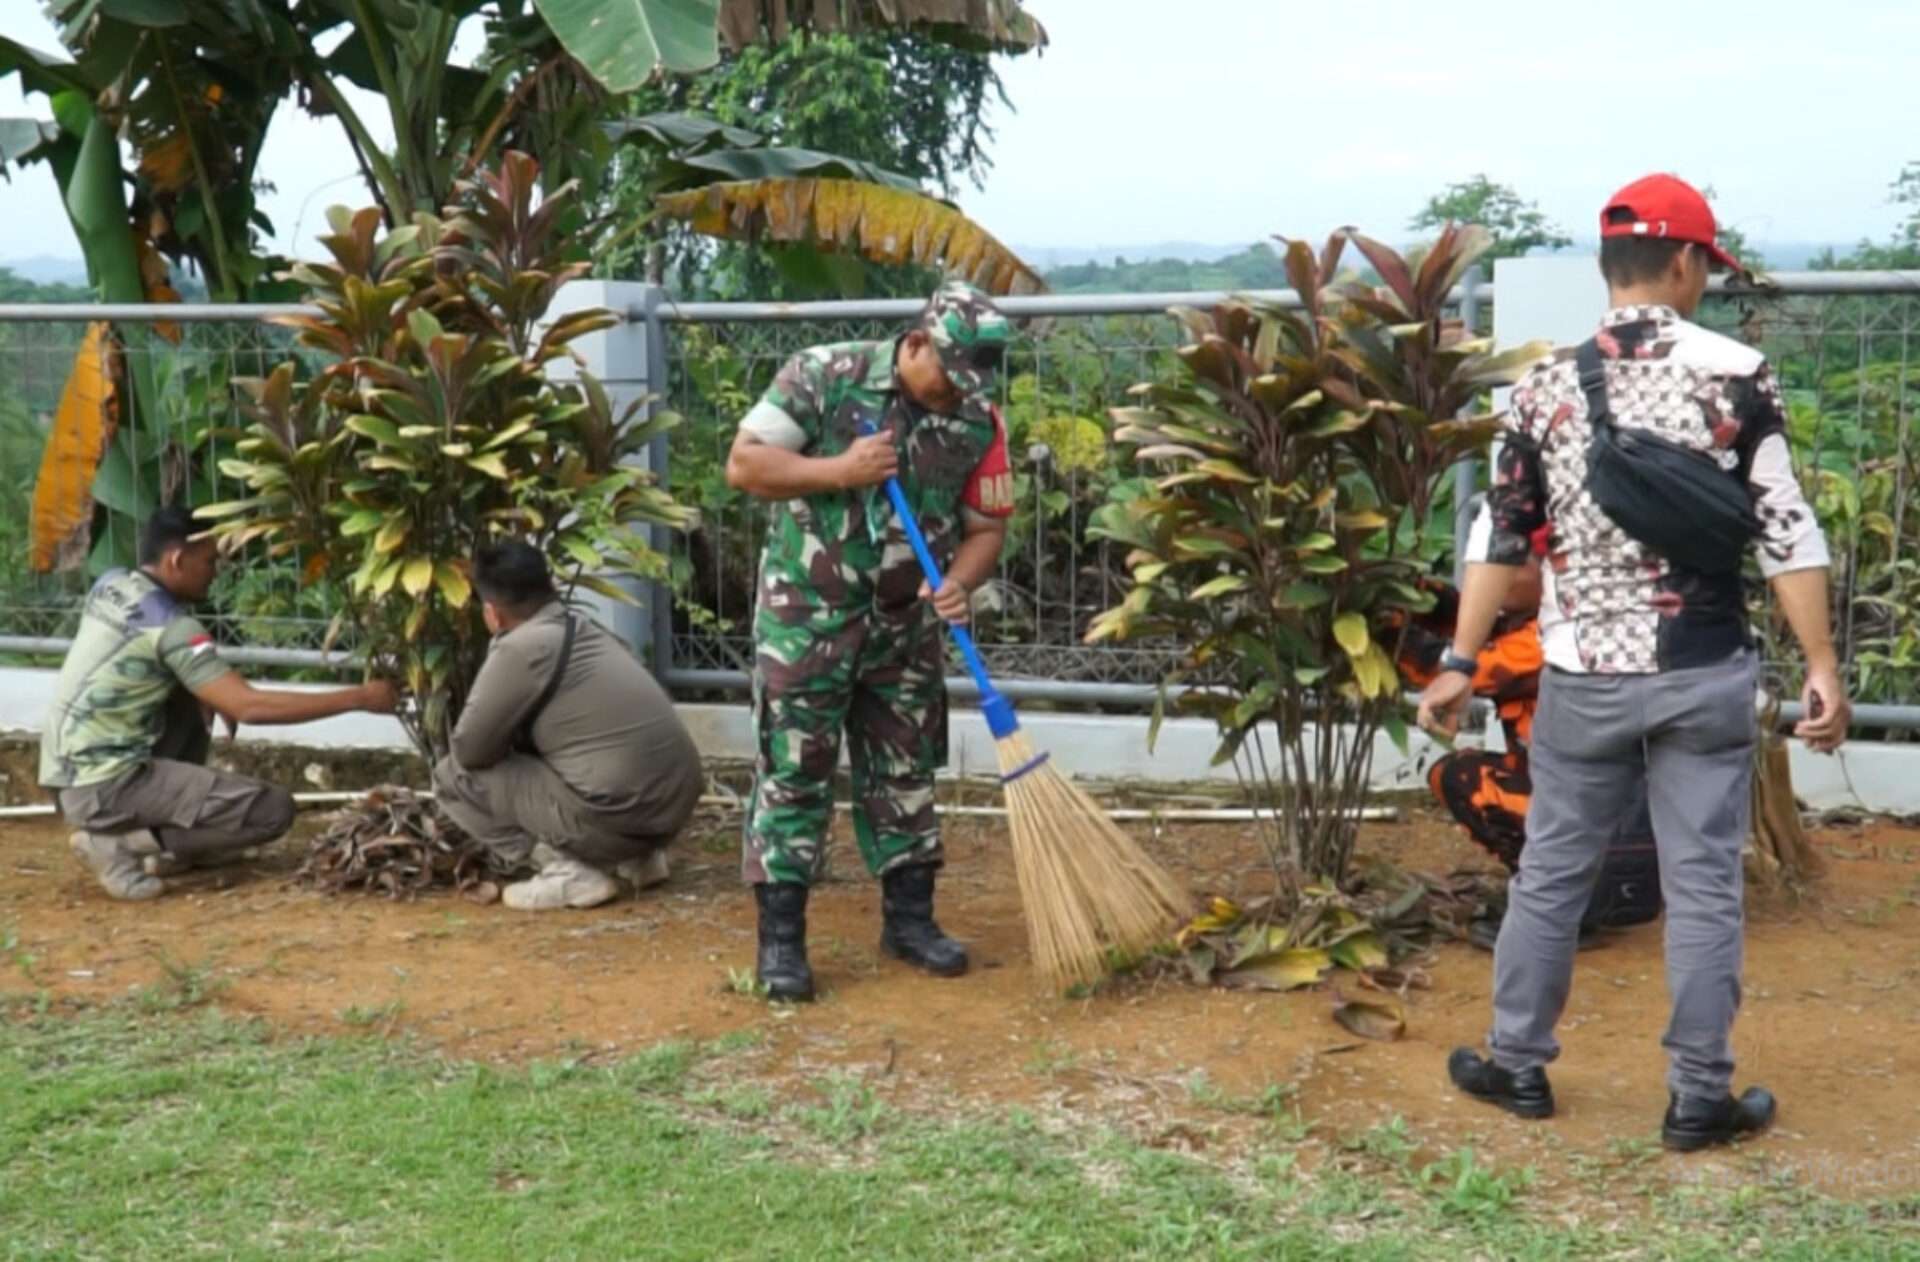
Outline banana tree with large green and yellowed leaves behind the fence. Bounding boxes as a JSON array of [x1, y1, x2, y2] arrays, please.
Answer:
[[0, 0, 1044, 567]]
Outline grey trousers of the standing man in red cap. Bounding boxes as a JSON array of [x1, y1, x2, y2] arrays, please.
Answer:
[[1490, 653, 1757, 1099]]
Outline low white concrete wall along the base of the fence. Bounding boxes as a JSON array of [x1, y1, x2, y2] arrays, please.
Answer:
[[0, 668, 1920, 814]]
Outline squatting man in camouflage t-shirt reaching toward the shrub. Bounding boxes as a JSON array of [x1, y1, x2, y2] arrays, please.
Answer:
[[40, 507, 394, 901]]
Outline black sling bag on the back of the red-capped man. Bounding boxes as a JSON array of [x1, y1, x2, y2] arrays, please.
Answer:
[[1574, 342, 1761, 574]]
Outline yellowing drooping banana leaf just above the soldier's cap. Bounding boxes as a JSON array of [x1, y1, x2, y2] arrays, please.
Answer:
[[659, 176, 1046, 294]]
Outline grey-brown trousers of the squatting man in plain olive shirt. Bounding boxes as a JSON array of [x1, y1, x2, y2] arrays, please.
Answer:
[[434, 753, 701, 868]]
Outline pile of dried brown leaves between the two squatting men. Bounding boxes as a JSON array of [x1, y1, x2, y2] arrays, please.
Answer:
[[294, 786, 507, 903]]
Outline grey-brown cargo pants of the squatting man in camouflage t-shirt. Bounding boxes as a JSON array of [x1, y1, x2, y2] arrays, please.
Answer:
[[60, 688, 294, 862]]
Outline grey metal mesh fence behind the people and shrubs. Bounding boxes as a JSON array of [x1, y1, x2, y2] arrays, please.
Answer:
[[0, 279, 1920, 705]]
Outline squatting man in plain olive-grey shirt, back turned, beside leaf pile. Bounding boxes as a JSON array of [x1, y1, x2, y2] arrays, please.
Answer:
[[434, 540, 705, 910]]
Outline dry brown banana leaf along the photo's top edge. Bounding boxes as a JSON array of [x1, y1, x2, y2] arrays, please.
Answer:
[[720, 0, 1046, 54]]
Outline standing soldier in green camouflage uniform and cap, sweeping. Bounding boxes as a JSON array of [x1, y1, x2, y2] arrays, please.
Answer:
[[728, 282, 1012, 999]]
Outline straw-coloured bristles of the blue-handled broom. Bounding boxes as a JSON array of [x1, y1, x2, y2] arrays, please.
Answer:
[[998, 732, 1190, 989]]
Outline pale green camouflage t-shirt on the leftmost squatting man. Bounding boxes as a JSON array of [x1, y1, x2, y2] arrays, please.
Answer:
[[40, 570, 230, 789]]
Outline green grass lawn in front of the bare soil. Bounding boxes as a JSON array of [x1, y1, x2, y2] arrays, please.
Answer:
[[0, 998, 1920, 1262]]
